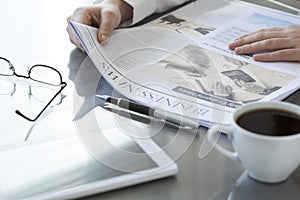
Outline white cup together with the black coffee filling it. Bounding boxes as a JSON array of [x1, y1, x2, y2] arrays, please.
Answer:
[[207, 102, 300, 183]]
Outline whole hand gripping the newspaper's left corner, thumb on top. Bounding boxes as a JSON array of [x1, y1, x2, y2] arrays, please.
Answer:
[[67, 0, 132, 50]]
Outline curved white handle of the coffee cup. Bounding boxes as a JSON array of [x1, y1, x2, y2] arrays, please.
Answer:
[[207, 124, 239, 161]]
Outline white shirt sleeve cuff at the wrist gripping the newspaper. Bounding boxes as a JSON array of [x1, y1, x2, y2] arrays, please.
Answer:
[[122, 0, 188, 26]]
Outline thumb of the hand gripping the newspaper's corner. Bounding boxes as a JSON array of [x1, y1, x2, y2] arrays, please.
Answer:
[[98, 10, 121, 45]]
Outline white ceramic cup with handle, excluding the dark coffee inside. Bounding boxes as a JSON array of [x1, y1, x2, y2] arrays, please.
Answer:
[[207, 102, 300, 183]]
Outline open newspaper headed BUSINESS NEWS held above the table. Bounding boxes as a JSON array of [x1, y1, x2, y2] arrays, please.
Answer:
[[71, 0, 300, 127]]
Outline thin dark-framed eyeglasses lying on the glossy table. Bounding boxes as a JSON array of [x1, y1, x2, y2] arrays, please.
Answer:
[[0, 57, 67, 121]]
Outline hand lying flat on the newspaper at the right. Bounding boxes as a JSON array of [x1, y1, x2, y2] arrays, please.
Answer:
[[229, 25, 300, 62]]
